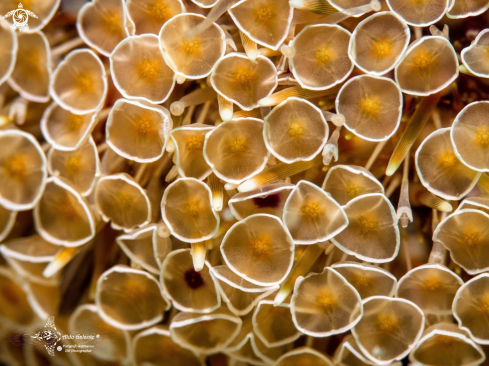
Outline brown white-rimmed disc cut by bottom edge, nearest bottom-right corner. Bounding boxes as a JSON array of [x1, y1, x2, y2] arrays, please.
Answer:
[[409, 323, 486, 366]]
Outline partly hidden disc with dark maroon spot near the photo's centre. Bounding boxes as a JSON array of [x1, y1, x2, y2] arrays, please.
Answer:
[[228, 183, 294, 220]]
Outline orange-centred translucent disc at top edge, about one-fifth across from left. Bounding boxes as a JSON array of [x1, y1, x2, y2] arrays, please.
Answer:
[[76, 0, 134, 57]]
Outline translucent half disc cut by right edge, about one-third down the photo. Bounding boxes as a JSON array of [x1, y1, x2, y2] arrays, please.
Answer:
[[450, 101, 489, 172]]
